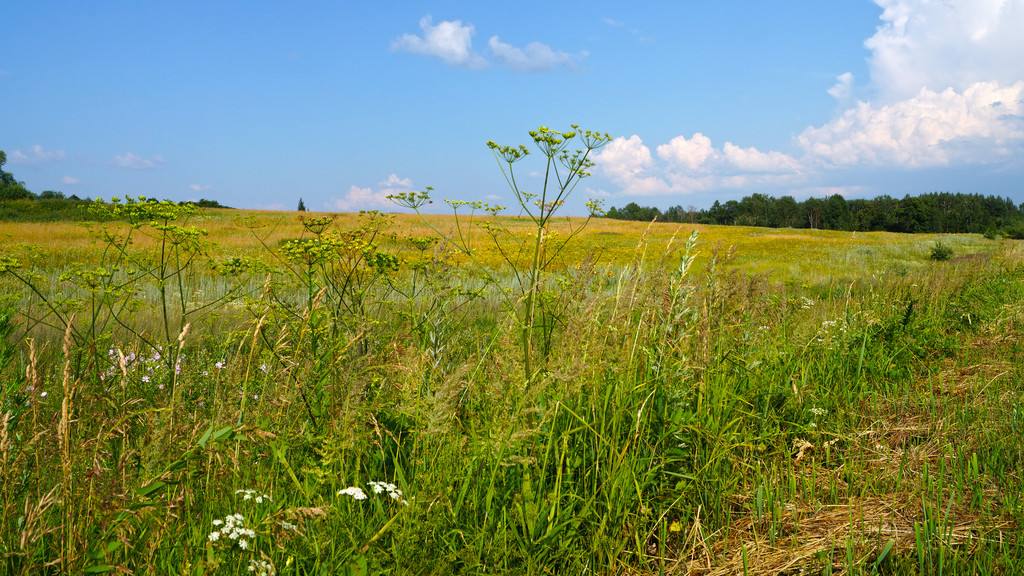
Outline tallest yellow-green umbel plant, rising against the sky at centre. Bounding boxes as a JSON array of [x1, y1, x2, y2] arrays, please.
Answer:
[[388, 124, 611, 382]]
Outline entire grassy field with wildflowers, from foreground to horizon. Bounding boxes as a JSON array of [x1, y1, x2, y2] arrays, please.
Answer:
[[0, 203, 1024, 575]]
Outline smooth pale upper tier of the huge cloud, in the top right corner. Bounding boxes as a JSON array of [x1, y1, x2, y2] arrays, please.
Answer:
[[864, 0, 1024, 104]]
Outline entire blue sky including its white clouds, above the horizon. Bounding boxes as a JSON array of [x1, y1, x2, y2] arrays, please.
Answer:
[[0, 0, 1024, 212]]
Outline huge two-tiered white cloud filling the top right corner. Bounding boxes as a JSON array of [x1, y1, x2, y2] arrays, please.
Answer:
[[797, 0, 1024, 168]]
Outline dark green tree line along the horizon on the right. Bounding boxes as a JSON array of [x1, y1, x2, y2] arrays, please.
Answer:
[[605, 192, 1024, 238]]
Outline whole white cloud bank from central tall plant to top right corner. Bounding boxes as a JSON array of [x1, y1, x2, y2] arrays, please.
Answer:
[[596, 0, 1024, 195]]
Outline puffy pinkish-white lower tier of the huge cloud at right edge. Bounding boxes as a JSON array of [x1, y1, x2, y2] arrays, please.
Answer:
[[797, 81, 1024, 167]]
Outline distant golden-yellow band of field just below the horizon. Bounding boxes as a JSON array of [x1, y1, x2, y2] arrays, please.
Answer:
[[0, 209, 998, 285]]
